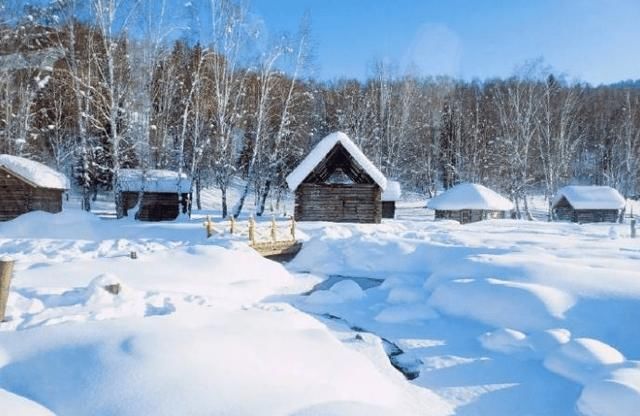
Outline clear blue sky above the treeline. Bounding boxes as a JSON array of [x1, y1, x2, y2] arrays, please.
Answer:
[[250, 0, 640, 84]]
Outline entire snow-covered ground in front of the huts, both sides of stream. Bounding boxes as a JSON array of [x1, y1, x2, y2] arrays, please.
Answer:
[[0, 197, 640, 416]]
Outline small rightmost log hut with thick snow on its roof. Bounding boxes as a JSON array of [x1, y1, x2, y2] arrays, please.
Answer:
[[551, 186, 625, 223]]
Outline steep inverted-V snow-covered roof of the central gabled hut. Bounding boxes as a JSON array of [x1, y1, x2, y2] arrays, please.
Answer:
[[287, 131, 387, 191]]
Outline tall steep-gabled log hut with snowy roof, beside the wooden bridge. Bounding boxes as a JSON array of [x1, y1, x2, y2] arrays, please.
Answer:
[[287, 132, 387, 223]]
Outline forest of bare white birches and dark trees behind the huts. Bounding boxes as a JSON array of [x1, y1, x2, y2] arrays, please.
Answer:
[[0, 0, 640, 217]]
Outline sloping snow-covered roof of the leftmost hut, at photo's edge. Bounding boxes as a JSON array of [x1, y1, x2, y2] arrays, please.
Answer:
[[0, 155, 69, 189]]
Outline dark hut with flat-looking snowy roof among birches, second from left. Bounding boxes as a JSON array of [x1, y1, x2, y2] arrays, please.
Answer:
[[116, 169, 191, 221]]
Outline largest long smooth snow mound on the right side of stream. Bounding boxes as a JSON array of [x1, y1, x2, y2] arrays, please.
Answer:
[[429, 279, 574, 331]]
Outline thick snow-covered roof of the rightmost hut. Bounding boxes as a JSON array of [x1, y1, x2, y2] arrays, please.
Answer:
[[553, 185, 625, 209]]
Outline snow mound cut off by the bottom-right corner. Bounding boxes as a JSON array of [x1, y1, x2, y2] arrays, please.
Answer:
[[578, 368, 640, 416]]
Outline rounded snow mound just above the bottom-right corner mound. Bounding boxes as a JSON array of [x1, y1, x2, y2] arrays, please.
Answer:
[[544, 338, 625, 384]]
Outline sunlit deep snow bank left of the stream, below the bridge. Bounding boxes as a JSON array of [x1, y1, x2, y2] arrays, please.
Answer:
[[0, 211, 452, 415]]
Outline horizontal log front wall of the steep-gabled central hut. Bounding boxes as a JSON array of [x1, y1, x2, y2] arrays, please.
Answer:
[[295, 183, 382, 223]]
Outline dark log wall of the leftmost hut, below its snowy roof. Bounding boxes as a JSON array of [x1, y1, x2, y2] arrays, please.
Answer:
[[0, 168, 64, 221]]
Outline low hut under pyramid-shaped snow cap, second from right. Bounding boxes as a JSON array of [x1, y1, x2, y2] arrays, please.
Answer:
[[427, 183, 513, 224]]
